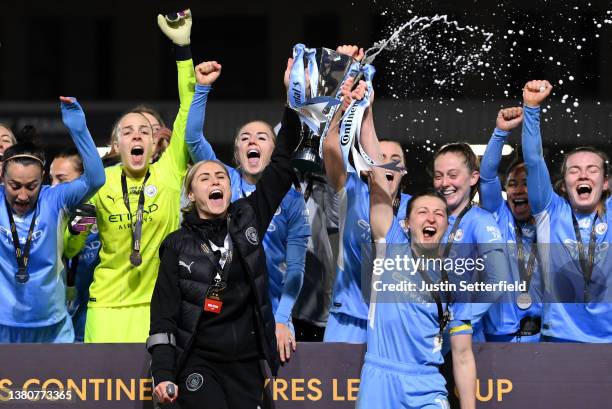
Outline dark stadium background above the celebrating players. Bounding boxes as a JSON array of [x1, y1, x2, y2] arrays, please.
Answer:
[[0, 0, 612, 190]]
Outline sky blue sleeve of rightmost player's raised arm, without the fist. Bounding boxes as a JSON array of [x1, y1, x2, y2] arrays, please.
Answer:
[[522, 105, 553, 214]]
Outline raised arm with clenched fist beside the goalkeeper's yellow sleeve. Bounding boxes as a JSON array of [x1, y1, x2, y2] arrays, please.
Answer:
[[185, 61, 221, 163]]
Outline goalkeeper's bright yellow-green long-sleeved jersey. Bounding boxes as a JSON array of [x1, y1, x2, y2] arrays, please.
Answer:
[[88, 60, 195, 308]]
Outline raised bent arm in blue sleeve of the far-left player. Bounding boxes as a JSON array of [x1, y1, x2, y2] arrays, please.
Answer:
[[55, 97, 106, 209]]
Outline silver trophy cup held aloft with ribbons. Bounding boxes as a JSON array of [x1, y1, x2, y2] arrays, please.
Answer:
[[289, 48, 357, 172]]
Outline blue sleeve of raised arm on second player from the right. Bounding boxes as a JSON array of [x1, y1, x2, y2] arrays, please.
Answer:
[[480, 128, 510, 213]]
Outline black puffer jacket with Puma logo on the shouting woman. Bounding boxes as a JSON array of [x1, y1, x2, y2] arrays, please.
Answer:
[[150, 108, 300, 384]]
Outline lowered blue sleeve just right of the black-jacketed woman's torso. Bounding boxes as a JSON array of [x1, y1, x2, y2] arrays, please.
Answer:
[[274, 194, 310, 323]]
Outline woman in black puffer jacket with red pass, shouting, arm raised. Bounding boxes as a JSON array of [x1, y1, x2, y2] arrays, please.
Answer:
[[147, 95, 300, 409]]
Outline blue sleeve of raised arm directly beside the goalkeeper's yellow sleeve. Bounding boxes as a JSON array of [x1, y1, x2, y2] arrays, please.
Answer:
[[185, 84, 217, 163]]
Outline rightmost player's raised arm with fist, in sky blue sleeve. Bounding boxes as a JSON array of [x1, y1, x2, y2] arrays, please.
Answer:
[[522, 80, 554, 214]]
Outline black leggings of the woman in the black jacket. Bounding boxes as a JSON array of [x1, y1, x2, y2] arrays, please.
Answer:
[[177, 356, 264, 409]]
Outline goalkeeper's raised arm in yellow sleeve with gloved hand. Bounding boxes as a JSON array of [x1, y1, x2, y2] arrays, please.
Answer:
[[157, 10, 195, 179]]
